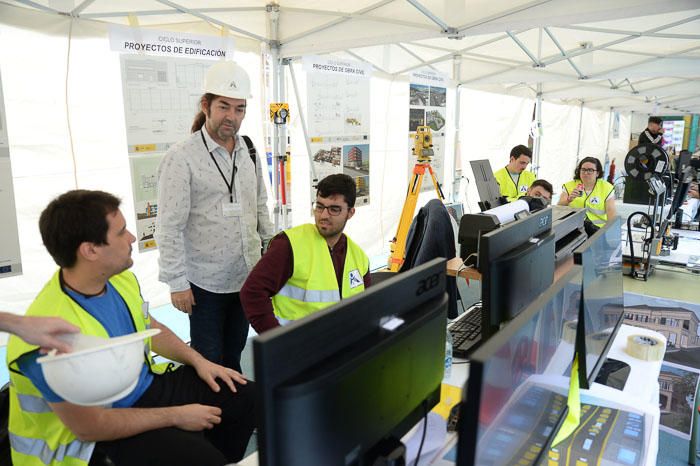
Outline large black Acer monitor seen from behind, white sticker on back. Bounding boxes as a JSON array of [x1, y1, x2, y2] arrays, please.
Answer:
[[253, 259, 447, 466]]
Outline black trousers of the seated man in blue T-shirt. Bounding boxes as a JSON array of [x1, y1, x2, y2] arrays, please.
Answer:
[[90, 366, 255, 466]]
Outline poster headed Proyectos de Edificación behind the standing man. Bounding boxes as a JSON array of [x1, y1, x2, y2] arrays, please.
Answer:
[[113, 29, 231, 251]]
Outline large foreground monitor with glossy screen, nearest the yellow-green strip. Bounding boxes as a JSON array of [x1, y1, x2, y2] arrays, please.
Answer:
[[457, 266, 581, 466]]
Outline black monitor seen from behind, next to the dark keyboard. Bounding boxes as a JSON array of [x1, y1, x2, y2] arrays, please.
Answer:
[[477, 207, 555, 340]]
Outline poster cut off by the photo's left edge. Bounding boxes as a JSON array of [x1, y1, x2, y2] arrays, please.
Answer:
[[0, 70, 22, 278]]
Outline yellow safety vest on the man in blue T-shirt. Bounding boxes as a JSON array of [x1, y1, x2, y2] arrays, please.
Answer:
[[7, 271, 163, 466]]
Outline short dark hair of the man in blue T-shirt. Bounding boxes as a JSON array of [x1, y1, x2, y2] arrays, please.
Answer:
[[39, 189, 121, 267]]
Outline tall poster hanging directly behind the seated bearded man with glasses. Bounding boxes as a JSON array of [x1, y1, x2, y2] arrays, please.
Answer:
[[304, 56, 371, 206]]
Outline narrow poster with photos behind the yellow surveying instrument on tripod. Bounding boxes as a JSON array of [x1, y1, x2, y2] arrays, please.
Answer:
[[408, 69, 447, 191]]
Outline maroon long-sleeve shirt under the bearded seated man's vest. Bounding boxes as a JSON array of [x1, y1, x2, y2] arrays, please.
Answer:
[[241, 232, 370, 333]]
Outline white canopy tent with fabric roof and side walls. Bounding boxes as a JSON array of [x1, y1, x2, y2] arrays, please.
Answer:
[[0, 0, 700, 312]]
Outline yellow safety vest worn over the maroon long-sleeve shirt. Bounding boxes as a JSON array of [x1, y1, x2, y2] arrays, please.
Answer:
[[272, 223, 369, 320]]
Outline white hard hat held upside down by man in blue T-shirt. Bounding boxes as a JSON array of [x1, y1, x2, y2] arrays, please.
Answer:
[[37, 329, 160, 406]]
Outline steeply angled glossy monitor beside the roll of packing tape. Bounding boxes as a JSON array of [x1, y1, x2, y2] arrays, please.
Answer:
[[574, 217, 624, 388]]
